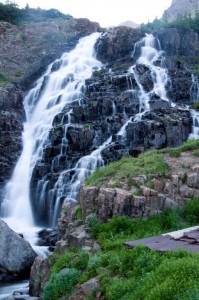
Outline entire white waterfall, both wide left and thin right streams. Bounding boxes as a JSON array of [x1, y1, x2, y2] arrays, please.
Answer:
[[0, 33, 180, 232]]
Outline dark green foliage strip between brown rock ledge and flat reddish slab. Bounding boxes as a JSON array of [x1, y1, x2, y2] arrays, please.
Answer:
[[95, 208, 186, 250]]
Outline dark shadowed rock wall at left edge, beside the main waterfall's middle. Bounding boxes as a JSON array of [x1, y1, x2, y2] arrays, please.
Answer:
[[0, 86, 25, 200]]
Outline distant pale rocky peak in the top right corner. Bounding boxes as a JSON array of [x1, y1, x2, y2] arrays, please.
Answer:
[[163, 0, 199, 21]]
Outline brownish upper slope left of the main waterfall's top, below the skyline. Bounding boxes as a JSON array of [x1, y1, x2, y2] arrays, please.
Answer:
[[0, 18, 99, 88]]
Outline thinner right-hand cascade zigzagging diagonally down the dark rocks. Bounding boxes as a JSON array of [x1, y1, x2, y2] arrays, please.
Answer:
[[53, 35, 172, 224]]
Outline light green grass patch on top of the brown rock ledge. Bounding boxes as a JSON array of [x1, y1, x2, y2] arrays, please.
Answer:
[[85, 151, 169, 185]]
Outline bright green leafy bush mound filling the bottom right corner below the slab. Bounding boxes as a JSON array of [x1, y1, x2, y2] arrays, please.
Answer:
[[133, 255, 199, 300]]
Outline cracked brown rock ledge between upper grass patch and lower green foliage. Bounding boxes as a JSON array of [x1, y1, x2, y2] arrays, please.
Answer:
[[78, 153, 199, 222]]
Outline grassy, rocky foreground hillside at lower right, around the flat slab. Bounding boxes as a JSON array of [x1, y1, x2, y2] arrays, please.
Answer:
[[30, 141, 199, 300]]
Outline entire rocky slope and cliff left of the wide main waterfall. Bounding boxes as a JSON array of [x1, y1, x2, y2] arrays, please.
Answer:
[[0, 19, 99, 202]]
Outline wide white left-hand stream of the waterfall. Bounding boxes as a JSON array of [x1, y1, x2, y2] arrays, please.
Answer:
[[1, 33, 101, 237]]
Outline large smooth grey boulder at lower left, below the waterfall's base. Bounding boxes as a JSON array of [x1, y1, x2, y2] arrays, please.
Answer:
[[0, 220, 37, 281]]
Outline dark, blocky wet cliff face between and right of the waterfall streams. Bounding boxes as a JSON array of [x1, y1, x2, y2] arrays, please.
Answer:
[[31, 27, 196, 223]]
